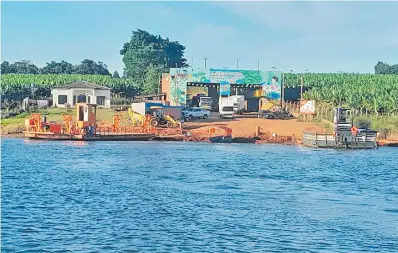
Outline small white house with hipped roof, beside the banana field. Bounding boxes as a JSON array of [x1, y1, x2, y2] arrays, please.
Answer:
[[51, 81, 111, 108]]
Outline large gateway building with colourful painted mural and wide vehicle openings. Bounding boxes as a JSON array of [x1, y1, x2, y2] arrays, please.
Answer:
[[162, 68, 282, 111]]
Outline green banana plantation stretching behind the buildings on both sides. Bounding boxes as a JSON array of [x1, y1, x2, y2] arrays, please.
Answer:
[[1, 73, 398, 114]]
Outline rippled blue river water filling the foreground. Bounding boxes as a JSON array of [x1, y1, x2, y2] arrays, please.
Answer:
[[1, 139, 398, 253]]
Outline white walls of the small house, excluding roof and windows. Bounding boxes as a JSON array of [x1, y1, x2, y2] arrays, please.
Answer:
[[51, 88, 111, 108]]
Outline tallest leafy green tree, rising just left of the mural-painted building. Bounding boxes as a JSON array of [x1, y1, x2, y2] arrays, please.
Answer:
[[120, 29, 188, 87]]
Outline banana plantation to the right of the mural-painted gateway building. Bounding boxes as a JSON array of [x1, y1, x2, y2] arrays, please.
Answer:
[[285, 74, 398, 115]]
